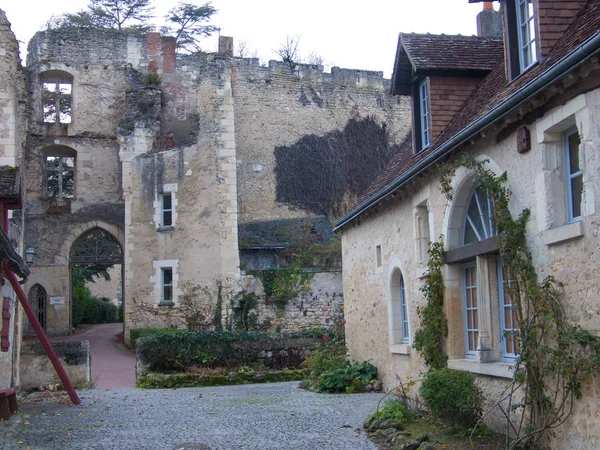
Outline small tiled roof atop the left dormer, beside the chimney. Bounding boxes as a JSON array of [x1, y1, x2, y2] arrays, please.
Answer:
[[400, 33, 503, 70]]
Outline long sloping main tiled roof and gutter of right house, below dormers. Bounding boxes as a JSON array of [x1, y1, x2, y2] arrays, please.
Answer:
[[336, 0, 600, 229]]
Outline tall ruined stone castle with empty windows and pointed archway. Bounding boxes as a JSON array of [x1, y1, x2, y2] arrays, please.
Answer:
[[23, 22, 409, 335]]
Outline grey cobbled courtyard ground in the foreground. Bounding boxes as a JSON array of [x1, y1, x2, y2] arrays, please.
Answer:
[[0, 382, 382, 450]]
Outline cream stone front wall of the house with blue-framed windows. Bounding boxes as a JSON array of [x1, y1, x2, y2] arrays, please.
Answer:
[[342, 89, 600, 450]]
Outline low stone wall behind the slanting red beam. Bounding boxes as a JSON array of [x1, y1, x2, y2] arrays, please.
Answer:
[[20, 341, 92, 389]]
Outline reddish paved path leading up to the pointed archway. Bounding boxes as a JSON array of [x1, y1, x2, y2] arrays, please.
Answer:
[[49, 323, 135, 390]]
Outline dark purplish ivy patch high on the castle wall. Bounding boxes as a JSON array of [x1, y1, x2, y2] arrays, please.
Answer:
[[275, 116, 399, 218]]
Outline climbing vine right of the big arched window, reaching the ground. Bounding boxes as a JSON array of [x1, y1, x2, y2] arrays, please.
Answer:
[[436, 156, 600, 449]]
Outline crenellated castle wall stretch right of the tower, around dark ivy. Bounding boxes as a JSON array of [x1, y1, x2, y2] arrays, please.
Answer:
[[232, 58, 410, 222]]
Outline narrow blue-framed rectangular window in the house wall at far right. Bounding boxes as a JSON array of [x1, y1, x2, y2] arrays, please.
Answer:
[[564, 128, 583, 222]]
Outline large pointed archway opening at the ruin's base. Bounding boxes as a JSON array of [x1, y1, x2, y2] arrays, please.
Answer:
[[69, 227, 124, 327]]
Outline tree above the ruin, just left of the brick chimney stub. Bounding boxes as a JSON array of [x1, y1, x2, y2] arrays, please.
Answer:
[[161, 2, 218, 52]]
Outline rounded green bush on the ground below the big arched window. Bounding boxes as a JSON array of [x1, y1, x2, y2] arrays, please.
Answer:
[[420, 369, 483, 427]]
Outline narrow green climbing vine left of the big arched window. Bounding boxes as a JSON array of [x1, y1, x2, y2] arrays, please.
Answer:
[[414, 238, 448, 369]]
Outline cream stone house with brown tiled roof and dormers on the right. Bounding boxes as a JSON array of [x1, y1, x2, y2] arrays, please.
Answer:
[[336, 0, 600, 449]]
